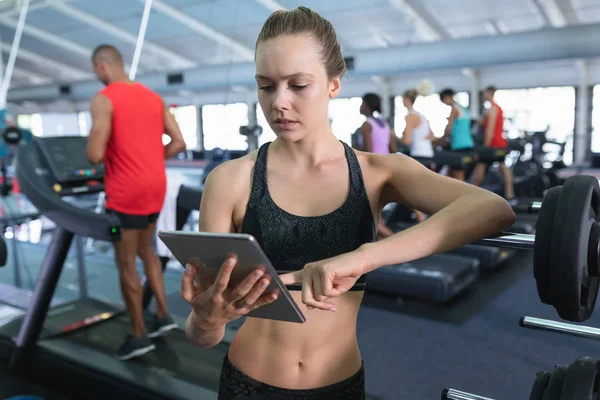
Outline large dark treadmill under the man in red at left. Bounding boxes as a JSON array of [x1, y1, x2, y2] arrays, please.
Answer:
[[0, 136, 226, 400]]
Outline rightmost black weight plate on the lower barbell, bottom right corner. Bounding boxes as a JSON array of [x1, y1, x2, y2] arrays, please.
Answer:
[[560, 357, 600, 400]]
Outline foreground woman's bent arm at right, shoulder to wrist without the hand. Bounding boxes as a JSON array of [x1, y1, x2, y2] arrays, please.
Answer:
[[359, 155, 516, 272]]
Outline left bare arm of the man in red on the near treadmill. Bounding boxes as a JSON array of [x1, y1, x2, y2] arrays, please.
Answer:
[[85, 94, 113, 164]]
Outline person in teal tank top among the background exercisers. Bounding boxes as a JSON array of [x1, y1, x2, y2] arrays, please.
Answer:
[[440, 89, 475, 181]]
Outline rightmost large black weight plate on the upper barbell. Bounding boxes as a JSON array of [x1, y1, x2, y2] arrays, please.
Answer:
[[550, 175, 600, 322]]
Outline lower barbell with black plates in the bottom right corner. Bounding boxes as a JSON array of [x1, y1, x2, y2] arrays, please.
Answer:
[[442, 357, 600, 400]]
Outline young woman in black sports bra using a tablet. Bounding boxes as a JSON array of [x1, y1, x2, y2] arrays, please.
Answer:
[[182, 7, 515, 400]]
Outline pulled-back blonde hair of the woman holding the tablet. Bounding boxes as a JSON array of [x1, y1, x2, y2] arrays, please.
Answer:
[[255, 7, 346, 79]]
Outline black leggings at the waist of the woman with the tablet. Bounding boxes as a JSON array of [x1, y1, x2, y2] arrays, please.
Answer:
[[219, 355, 366, 400]]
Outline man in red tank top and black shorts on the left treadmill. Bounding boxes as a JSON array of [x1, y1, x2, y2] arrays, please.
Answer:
[[86, 45, 185, 360]]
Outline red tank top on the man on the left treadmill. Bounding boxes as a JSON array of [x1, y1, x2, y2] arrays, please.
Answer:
[[100, 82, 167, 215]]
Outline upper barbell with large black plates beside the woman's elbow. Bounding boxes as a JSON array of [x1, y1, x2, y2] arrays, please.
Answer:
[[475, 175, 600, 322]]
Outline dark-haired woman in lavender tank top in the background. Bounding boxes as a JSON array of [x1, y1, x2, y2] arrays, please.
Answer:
[[359, 93, 397, 239]]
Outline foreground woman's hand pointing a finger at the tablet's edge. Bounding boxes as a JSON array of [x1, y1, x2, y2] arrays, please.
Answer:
[[280, 249, 367, 311]]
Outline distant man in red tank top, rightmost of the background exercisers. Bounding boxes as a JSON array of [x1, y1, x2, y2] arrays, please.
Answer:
[[473, 86, 515, 203]]
